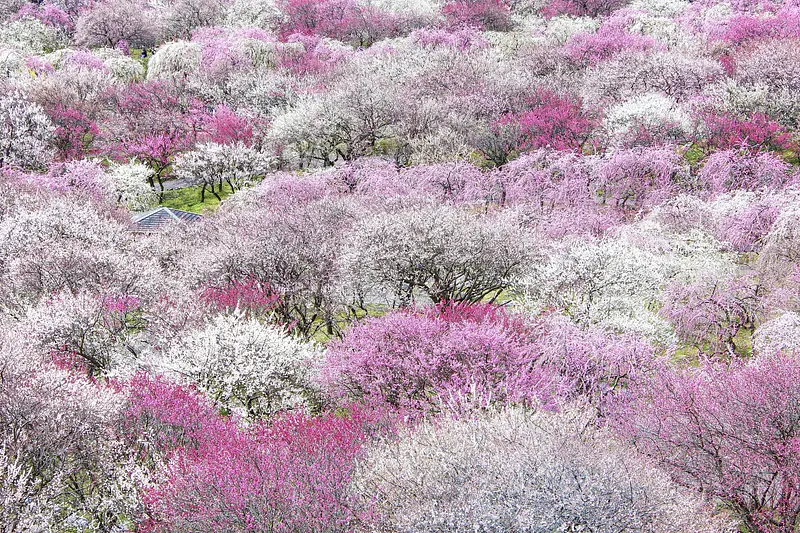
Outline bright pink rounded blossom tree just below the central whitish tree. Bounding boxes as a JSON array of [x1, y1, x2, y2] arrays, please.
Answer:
[[322, 304, 561, 416]]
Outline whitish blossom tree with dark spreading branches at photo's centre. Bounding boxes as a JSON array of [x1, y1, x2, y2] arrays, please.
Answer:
[[343, 207, 533, 305]]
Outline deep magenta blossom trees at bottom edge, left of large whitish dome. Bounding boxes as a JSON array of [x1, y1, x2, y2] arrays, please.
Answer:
[[123, 376, 386, 533]]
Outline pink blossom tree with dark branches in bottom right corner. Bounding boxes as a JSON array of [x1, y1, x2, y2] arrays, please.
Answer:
[[614, 356, 800, 533]]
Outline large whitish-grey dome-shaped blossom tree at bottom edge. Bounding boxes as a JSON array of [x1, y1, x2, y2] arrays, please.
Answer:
[[355, 410, 734, 533]]
